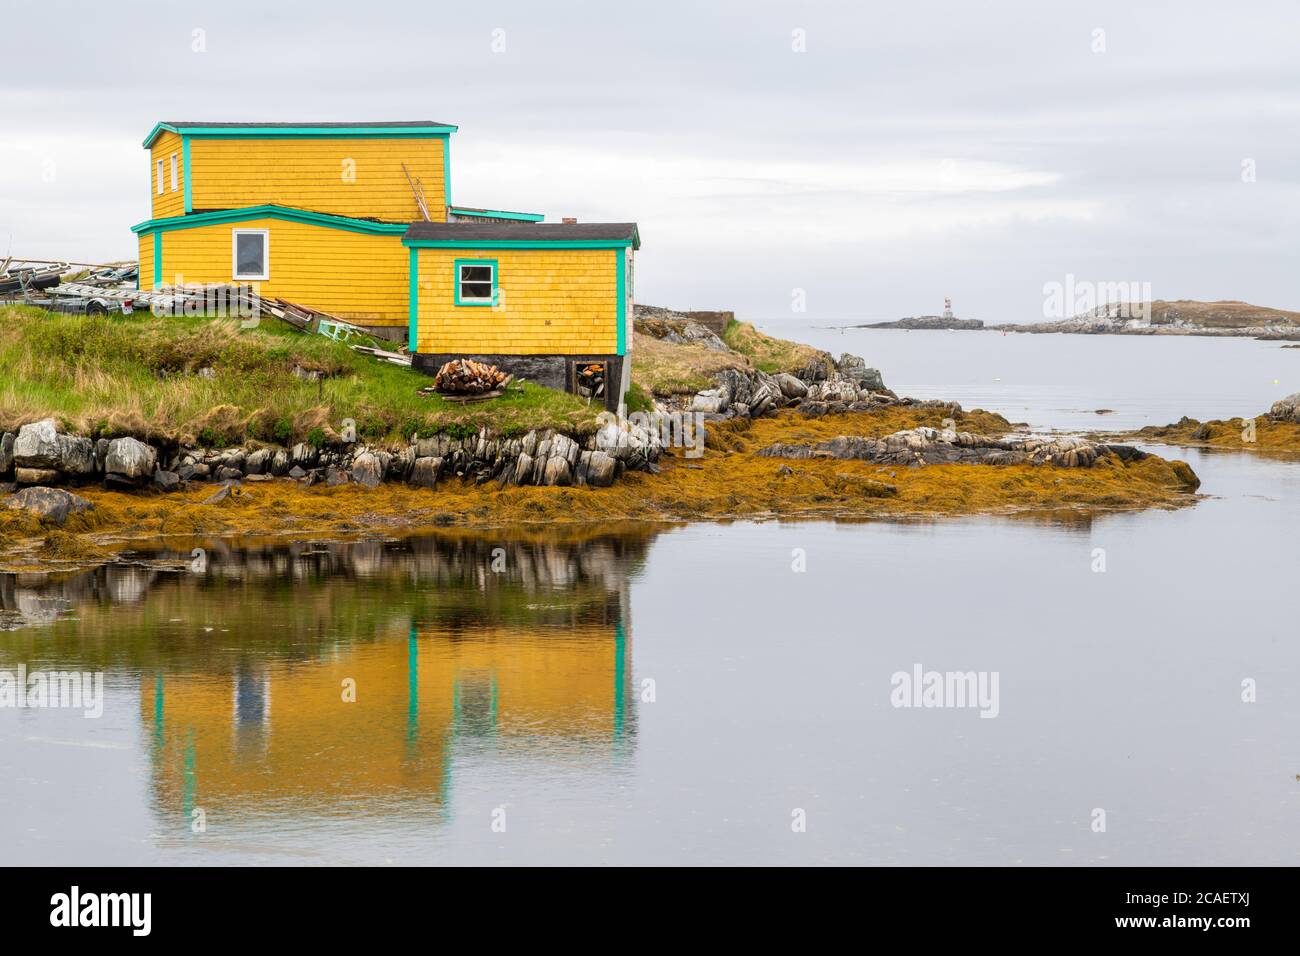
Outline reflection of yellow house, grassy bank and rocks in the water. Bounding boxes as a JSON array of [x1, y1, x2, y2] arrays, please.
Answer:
[[0, 533, 649, 821]]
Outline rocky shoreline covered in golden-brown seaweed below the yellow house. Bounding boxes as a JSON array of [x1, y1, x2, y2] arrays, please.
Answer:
[[0, 320, 1199, 567]]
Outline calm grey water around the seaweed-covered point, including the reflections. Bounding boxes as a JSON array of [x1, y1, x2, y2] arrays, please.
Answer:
[[0, 333, 1300, 865]]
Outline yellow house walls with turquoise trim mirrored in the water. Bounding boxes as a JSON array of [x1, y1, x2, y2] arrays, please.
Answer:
[[140, 626, 625, 809]]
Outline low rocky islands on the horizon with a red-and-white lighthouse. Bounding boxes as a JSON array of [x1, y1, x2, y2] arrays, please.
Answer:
[[852, 299, 1300, 342]]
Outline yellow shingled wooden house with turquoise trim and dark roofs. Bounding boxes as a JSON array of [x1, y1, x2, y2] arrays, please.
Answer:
[[131, 121, 640, 408]]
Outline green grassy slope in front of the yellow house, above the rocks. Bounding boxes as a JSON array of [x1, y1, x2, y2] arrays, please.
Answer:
[[0, 306, 601, 445]]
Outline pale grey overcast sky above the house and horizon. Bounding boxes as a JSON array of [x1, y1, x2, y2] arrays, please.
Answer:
[[0, 0, 1300, 321]]
